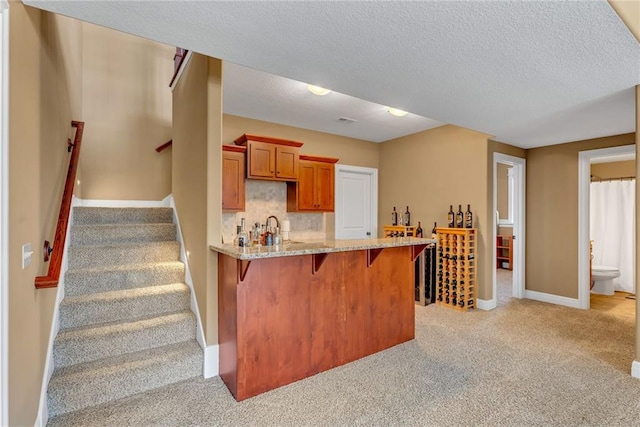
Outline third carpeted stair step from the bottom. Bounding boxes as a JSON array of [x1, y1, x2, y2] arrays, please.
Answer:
[[60, 283, 190, 329]]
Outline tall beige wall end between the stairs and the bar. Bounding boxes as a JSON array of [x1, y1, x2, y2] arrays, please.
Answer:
[[172, 54, 222, 345]]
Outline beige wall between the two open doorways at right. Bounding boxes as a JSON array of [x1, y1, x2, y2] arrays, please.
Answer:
[[526, 134, 635, 298]]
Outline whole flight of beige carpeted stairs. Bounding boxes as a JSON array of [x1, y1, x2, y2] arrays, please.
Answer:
[[47, 207, 203, 417]]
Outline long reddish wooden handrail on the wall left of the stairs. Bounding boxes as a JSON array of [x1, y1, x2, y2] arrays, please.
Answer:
[[35, 121, 84, 289]]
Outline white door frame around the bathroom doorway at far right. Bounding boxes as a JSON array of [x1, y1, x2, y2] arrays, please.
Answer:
[[578, 145, 636, 309]]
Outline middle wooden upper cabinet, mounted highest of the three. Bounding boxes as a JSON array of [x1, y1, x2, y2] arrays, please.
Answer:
[[234, 133, 303, 181]]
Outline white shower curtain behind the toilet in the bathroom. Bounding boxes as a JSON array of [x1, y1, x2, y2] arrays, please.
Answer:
[[589, 179, 636, 294]]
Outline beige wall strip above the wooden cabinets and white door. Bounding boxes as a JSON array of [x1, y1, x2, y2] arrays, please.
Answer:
[[222, 114, 380, 168]]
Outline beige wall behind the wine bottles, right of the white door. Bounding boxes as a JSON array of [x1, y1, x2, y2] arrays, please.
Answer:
[[378, 125, 493, 299]]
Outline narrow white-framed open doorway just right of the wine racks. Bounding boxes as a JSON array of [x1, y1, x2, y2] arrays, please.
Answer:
[[490, 153, 526, 308]]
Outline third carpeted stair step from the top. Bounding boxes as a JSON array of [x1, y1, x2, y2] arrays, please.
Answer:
[[68, 241, 180, 269]]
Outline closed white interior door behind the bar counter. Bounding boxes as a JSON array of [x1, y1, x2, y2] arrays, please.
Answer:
[[335, 165, 378, 239]]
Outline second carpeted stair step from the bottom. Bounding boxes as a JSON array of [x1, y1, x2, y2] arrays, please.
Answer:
[[53, 311, 196, 367]]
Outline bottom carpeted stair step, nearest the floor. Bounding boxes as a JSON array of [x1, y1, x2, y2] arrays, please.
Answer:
[[47, 339, 203, 417]]
